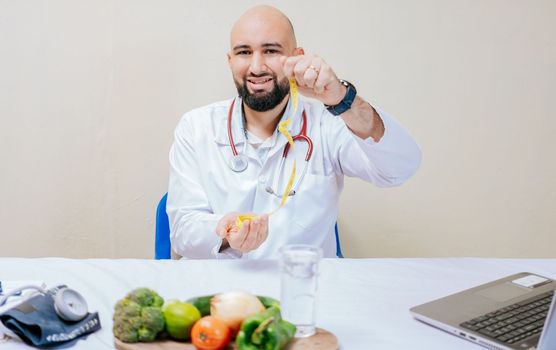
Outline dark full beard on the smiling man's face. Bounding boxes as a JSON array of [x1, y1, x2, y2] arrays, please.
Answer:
[[234, 75, 290, 112]]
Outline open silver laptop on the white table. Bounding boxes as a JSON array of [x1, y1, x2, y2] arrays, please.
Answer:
[[410, 272, 556, 350]]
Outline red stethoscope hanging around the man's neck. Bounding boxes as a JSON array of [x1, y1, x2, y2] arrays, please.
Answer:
[[228, 99, 313, 197]]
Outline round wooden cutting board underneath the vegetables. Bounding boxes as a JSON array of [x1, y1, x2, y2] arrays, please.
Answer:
[[114, 328, 338, 350]]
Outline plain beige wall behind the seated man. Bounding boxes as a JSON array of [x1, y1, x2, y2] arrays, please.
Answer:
[[0, 0, 556, 258]]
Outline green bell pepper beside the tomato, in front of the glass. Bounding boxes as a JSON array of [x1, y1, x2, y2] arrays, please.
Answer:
[[236, 305, 296, 350]]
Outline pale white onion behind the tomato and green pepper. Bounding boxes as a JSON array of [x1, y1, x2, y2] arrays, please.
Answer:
[[210, 292, 265, 336]]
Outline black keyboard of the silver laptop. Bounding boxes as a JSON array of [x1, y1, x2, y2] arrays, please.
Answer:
[[460, 291, 554, 344]]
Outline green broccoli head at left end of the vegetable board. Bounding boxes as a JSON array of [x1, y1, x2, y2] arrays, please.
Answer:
[[112, 288, 164, 343]]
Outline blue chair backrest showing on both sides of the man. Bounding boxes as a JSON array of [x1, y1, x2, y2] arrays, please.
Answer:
[[154, 193, 344, 260]]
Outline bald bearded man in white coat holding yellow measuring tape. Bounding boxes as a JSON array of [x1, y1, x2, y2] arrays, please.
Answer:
[[167, 6, 421, 259]]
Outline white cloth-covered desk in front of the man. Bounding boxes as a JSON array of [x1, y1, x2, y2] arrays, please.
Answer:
[[0, 258, 556, 350]]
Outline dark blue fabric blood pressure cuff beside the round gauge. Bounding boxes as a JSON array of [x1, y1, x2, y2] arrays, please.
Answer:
[[0, 293, 100, 349]]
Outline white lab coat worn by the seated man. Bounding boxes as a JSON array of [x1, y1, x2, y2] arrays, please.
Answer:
[[166, 98, 421, 259]]
